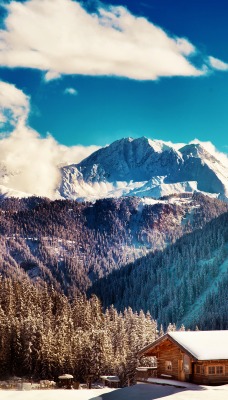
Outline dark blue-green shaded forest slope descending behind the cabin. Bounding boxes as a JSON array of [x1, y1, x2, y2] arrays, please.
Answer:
[[90, 213, 228, 330]]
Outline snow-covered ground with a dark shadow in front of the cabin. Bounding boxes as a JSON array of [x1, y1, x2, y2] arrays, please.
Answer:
[[0, 384, 228, 400]]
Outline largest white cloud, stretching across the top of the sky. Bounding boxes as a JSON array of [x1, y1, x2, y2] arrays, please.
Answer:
[[0, 0, 206, 81]]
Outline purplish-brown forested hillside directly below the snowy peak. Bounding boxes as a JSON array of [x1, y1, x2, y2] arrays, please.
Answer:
[[0, 193, 228, 294]]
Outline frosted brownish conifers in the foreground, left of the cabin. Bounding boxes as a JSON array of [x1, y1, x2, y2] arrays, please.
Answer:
[[0, 278, 158, 385]]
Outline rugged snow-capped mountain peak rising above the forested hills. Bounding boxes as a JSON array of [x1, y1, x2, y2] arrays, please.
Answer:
[[58, 137, 228, 200]]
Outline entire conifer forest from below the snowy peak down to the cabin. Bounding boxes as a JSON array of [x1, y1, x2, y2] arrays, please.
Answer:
[[0, 194, 228, 385]]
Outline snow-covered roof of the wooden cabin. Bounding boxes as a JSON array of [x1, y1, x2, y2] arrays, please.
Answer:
[[139, 330, 228, 361]]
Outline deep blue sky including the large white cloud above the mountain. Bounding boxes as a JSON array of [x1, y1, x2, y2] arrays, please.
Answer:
[[0, 0, 228, 152]]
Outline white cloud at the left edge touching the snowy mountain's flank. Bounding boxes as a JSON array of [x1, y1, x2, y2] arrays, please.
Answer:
[[0, 82, 98, 198]]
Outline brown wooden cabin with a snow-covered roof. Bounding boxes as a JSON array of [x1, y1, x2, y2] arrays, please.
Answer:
[[139, 330, 228, 385]]
